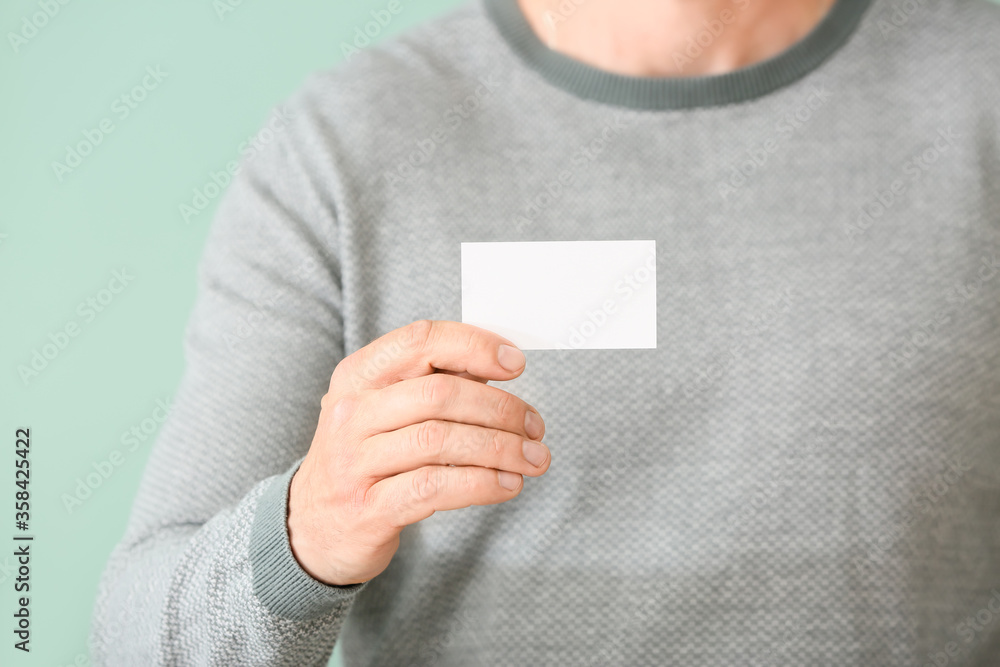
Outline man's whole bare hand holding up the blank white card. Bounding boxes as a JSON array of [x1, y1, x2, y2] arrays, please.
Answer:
[[288, 320, 551, 585]]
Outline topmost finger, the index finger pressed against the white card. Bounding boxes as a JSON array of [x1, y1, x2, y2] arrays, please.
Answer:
[[334, 320, 525, 391]]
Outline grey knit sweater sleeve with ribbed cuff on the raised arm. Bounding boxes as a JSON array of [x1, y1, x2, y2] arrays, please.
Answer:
[[90, 79, 367, 665]]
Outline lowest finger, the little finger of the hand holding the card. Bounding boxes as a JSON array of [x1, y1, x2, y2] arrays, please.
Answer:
[[368, 466, 524, 528]]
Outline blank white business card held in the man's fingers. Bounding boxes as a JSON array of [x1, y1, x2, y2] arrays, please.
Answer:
[[462, 241, 656, 350]]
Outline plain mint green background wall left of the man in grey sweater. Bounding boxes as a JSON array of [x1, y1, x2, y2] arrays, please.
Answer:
[[0, 0, 460, 666]]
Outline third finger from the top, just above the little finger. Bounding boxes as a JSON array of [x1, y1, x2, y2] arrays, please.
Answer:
[[358, 419, 552, 479]]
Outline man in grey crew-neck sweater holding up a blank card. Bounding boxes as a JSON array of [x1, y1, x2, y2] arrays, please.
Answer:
[[93, 0, 1000, 667]]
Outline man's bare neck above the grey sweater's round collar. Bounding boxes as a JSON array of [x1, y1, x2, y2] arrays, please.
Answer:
[[517, 0, 834, 77]]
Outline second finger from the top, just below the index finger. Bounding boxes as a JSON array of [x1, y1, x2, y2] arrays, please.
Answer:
[[359, 373, 545, 440]]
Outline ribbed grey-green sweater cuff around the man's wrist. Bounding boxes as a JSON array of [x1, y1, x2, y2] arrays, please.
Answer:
[[250, 459, 368, 621]]
